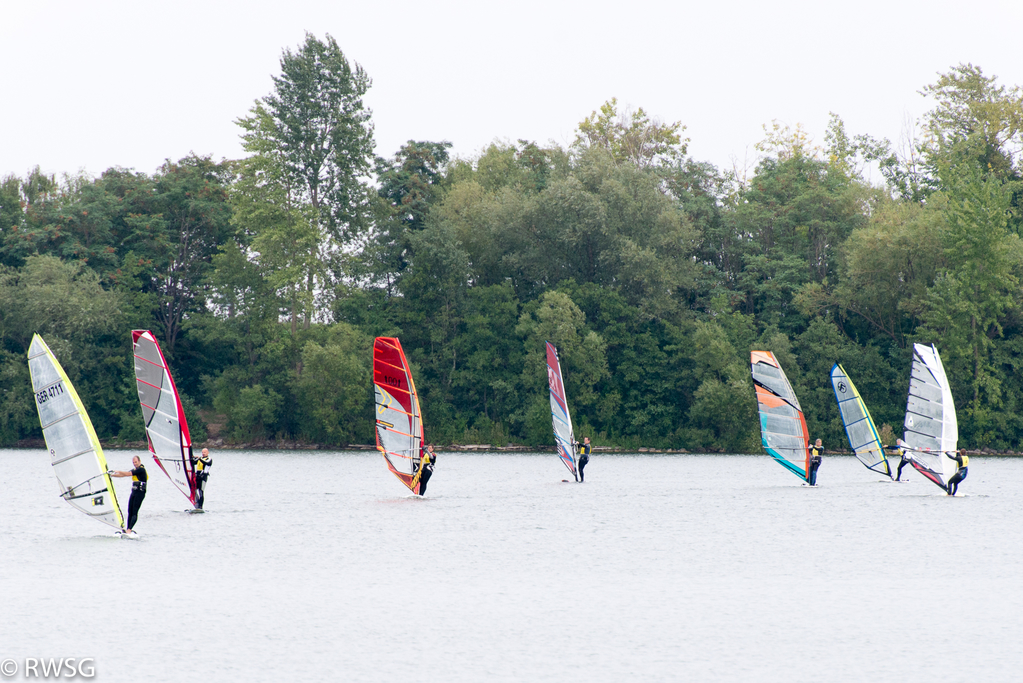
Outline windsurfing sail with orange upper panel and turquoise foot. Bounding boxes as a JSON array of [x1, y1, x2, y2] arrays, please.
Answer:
[[750, 351, 810, 481]]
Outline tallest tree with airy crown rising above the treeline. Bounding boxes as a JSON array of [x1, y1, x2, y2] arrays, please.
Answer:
[[236, 34, 373, 327]]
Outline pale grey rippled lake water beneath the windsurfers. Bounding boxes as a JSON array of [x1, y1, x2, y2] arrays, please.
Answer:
[[0, 450, 1023, 683]]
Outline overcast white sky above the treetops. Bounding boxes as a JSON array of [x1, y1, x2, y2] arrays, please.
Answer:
[[0, 0, 1023, 183]]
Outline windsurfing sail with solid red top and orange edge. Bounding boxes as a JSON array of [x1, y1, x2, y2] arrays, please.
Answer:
[[373, 336, 422, 494]]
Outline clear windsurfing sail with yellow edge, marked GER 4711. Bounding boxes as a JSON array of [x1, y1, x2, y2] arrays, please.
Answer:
[[29, 334, 125, 529]]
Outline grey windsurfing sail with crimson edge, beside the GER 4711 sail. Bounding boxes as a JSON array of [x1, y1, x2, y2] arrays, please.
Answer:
[[131, 329, 196, 507]]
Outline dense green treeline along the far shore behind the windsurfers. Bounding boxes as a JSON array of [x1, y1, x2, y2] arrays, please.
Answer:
[[0, 36, 1023, 451]]
